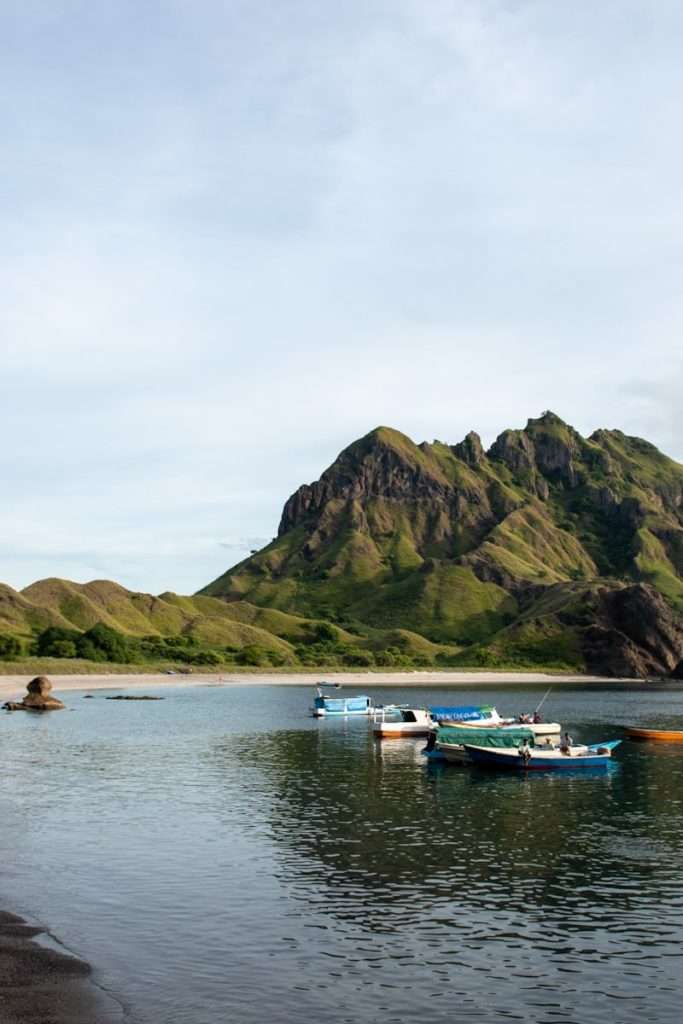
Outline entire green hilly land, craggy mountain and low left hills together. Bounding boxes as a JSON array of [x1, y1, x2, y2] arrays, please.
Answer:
[[5, 413, 683, 676]]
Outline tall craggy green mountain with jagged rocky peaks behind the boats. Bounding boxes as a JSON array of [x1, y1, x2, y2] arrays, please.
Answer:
[[201, 412, 683, 676]]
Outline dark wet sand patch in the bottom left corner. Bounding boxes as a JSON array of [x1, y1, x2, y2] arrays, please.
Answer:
[[0, 910, 125, 1024]]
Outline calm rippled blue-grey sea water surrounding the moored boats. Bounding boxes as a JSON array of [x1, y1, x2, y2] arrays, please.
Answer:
[[0, 684, 683, 1024]]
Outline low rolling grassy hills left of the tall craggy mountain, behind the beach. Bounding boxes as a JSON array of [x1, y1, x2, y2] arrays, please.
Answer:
[[0, 579, 457, 666]]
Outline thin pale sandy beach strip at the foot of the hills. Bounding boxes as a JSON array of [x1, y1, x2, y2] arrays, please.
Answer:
[[0, 670, 648, 700]]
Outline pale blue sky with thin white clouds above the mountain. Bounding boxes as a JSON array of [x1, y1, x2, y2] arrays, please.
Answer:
[[0, 0, 683, 593]]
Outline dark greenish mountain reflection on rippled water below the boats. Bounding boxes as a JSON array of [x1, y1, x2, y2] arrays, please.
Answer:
[[212, 730, 683, 915]]
